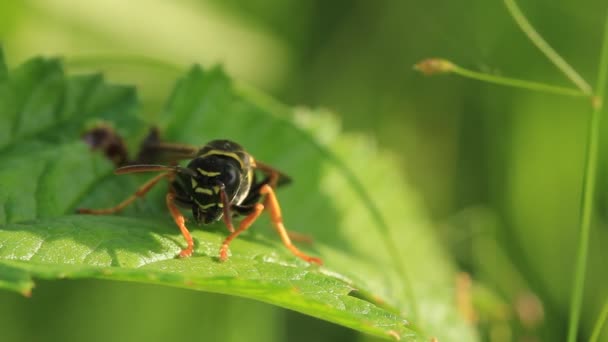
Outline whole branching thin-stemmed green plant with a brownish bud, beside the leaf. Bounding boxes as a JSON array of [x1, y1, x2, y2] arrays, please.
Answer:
[[416, 0, 608, 342]]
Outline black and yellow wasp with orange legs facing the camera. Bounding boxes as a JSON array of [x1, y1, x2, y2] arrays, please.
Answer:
[[78, 130, 322, 265]]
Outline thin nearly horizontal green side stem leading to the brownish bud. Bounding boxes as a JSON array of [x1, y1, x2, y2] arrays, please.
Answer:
[[452, 65, 588, 97]]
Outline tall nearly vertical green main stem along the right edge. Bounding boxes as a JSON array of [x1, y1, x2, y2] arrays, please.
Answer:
[[568, 7, 608, 342]]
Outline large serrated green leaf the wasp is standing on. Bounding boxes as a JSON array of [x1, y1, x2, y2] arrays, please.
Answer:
[[0, 51, 475, 340]]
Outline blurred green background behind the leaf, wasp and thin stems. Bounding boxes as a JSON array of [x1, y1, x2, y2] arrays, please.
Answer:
[[0, 0, 608, 341]]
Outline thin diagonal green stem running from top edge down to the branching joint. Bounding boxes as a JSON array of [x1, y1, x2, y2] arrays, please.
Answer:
[[505, 0, 592, 95]]
